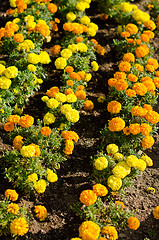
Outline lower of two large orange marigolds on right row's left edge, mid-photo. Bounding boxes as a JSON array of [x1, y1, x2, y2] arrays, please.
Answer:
[[108, 117, 125, 132]]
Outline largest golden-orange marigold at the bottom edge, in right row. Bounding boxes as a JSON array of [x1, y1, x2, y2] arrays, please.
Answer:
[[79, 221, 100, 240]]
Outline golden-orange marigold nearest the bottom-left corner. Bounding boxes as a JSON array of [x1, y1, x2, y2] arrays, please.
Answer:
[[10, 217, 29, 236]]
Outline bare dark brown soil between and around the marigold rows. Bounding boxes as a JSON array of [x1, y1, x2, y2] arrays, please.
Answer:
[[0, 1, 159, 240]]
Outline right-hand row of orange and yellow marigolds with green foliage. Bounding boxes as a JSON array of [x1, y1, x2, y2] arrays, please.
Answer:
[[71, 1, 159, 240]]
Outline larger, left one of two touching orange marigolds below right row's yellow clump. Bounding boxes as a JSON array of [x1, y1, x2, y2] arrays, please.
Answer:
[[79, 190, 97, 206]]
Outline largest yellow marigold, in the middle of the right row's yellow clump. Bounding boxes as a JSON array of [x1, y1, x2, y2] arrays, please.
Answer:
[[112, 161, 131, 178]]
